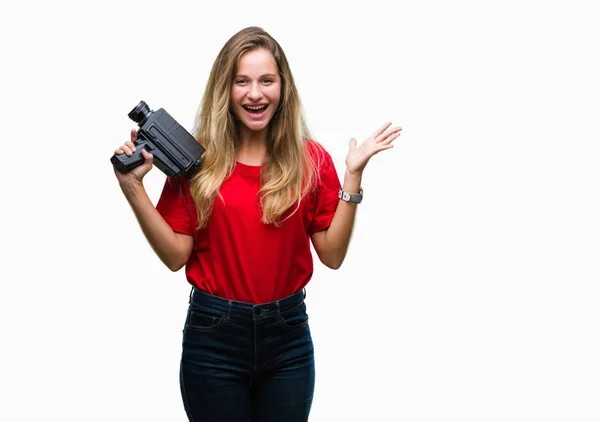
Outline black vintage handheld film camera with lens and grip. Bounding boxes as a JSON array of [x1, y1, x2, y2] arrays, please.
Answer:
[[110, 101, 205, 177]]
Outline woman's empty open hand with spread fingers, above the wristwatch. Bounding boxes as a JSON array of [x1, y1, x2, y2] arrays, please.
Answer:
[[346, 122, 402, 176]]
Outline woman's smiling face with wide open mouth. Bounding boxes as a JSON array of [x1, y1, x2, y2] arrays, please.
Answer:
[[231, 48, 281, 136]]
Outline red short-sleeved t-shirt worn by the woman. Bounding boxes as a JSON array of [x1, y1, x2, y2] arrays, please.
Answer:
[[156, 143, 341, 304]]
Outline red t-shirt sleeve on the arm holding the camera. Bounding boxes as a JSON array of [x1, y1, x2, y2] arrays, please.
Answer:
[[156, 177, 193, 236]]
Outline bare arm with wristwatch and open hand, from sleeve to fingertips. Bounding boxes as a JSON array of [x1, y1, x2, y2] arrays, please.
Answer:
[[311, 123, 402, 270]]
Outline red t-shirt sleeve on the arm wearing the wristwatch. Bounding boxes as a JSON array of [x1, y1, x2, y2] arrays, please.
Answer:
[[309, 148, 342, 234]]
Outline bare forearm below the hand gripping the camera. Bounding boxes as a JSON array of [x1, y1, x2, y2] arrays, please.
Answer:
[[121, 182, 189, 271]]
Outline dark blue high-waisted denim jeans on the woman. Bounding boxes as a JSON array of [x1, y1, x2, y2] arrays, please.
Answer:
[[180, 288, 315, 422]]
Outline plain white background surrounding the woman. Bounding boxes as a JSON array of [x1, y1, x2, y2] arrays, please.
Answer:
[[0, 0, 600, 422]]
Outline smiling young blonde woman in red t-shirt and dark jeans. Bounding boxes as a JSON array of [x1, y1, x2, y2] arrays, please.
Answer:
[[115, 27, 401, 422]]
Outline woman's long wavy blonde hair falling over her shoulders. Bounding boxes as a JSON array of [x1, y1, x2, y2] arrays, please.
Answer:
[[190, 27, 318, 228]]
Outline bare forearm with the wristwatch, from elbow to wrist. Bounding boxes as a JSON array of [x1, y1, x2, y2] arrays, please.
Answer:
[[320, 170, 362, 268]]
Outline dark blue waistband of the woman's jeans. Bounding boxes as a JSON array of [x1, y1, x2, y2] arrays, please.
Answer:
[[190, 287, 306, 318]]
